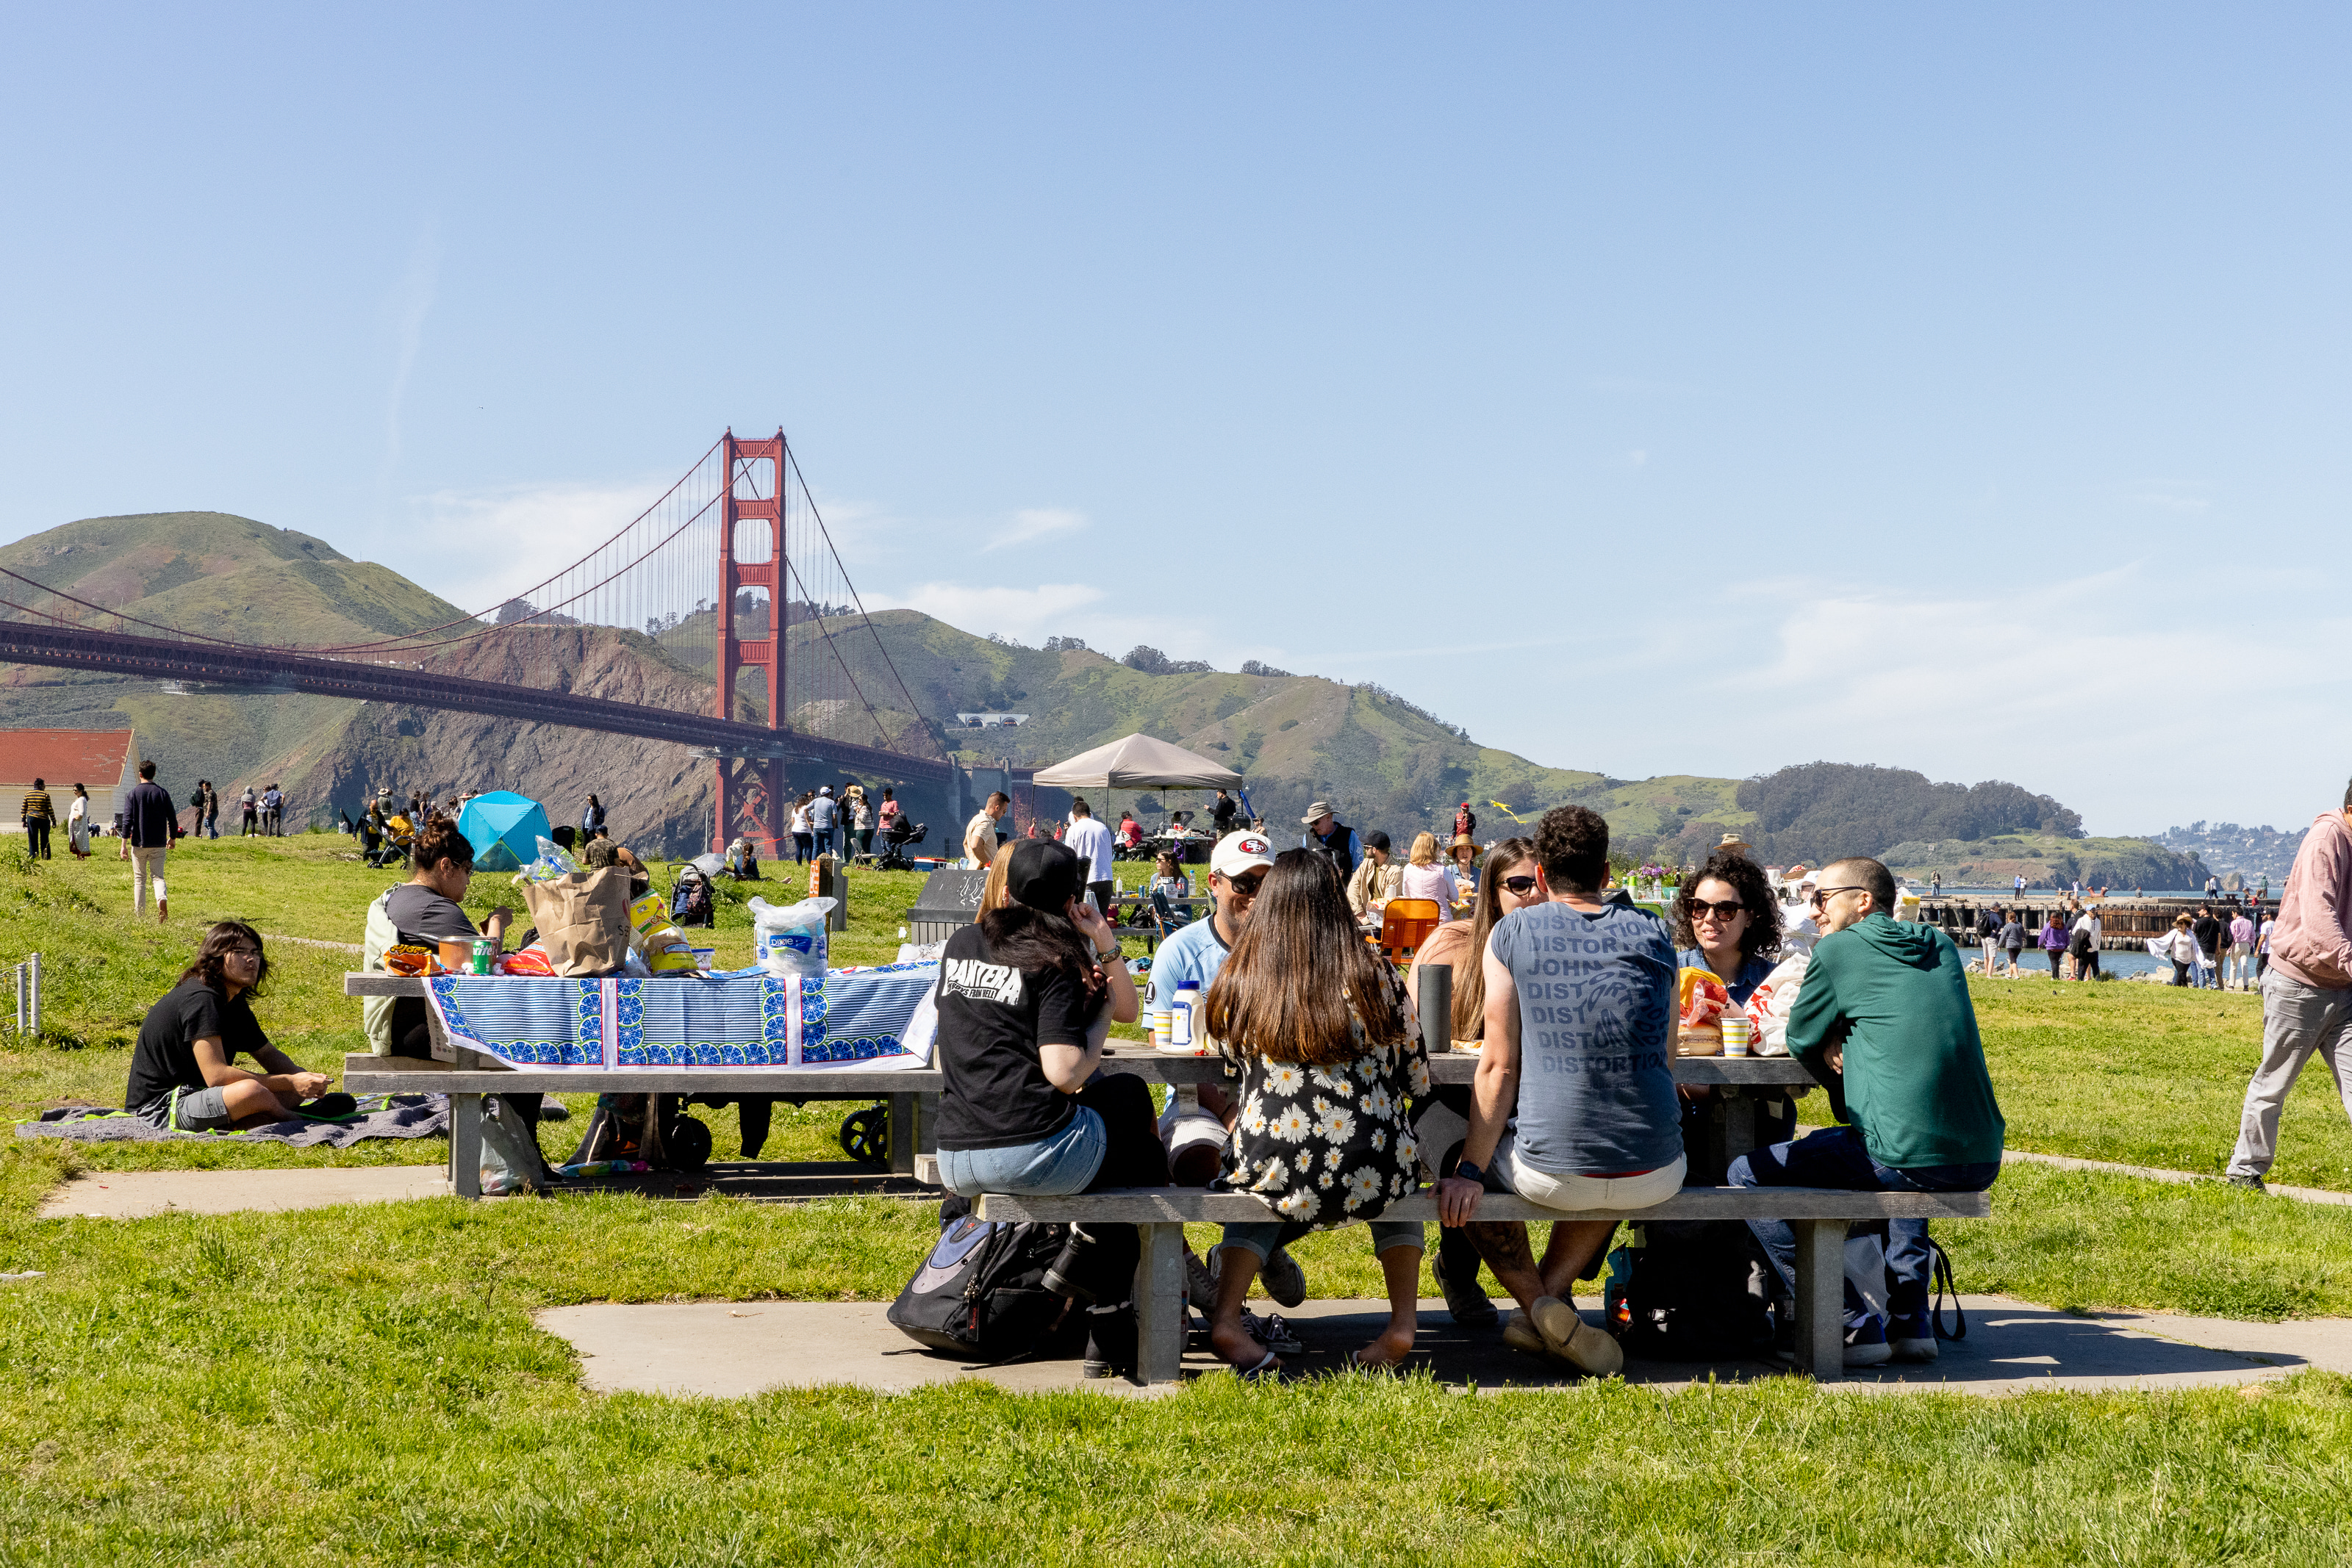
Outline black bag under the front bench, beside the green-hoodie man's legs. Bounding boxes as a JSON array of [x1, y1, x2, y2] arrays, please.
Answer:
[[1609, 1220, 1771, 1361]]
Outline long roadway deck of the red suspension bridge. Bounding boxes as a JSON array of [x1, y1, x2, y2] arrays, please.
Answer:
[[0, 621, 950, 783]]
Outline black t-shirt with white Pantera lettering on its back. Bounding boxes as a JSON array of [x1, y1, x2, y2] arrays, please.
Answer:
[[933, 927, 1105, 1150]]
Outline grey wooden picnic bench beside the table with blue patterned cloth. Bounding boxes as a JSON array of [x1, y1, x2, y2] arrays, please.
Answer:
[[343, 974, 948, 1199]]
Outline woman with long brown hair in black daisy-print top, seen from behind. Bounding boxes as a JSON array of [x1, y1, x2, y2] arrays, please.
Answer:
[[1202, 849, 1430, 1378]]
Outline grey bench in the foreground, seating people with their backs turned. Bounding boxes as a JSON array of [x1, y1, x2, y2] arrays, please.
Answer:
[[974, 1187, 1992, 1382]]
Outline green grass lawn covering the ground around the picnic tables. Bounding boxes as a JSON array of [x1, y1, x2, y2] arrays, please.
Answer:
[[0, 837, 2352, 1568]]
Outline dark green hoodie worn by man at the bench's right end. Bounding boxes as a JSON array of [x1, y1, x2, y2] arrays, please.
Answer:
[[1788, 912, 2004, 1170]]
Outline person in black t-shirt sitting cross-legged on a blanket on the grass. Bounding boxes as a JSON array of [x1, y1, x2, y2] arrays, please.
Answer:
[[122, 919, 355, 1133]]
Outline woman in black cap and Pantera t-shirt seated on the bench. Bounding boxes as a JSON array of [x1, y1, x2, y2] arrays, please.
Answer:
[[933, 839, 1169, 1375]]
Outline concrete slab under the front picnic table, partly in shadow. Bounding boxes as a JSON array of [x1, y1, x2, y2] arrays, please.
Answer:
[[537, 1295, 2352, 1399]]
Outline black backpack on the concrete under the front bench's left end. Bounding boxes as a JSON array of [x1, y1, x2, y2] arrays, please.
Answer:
[[889, 1213, 1084, 1361]]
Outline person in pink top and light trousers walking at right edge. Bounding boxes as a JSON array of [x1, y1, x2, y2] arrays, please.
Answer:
[[2227, 785, 2352, 1192]]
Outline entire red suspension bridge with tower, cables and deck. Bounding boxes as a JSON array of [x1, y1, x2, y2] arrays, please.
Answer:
[[0, 430, 957, 849]]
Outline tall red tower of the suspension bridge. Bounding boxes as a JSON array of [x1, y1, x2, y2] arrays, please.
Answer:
[[710, 430, 786, 858]]
